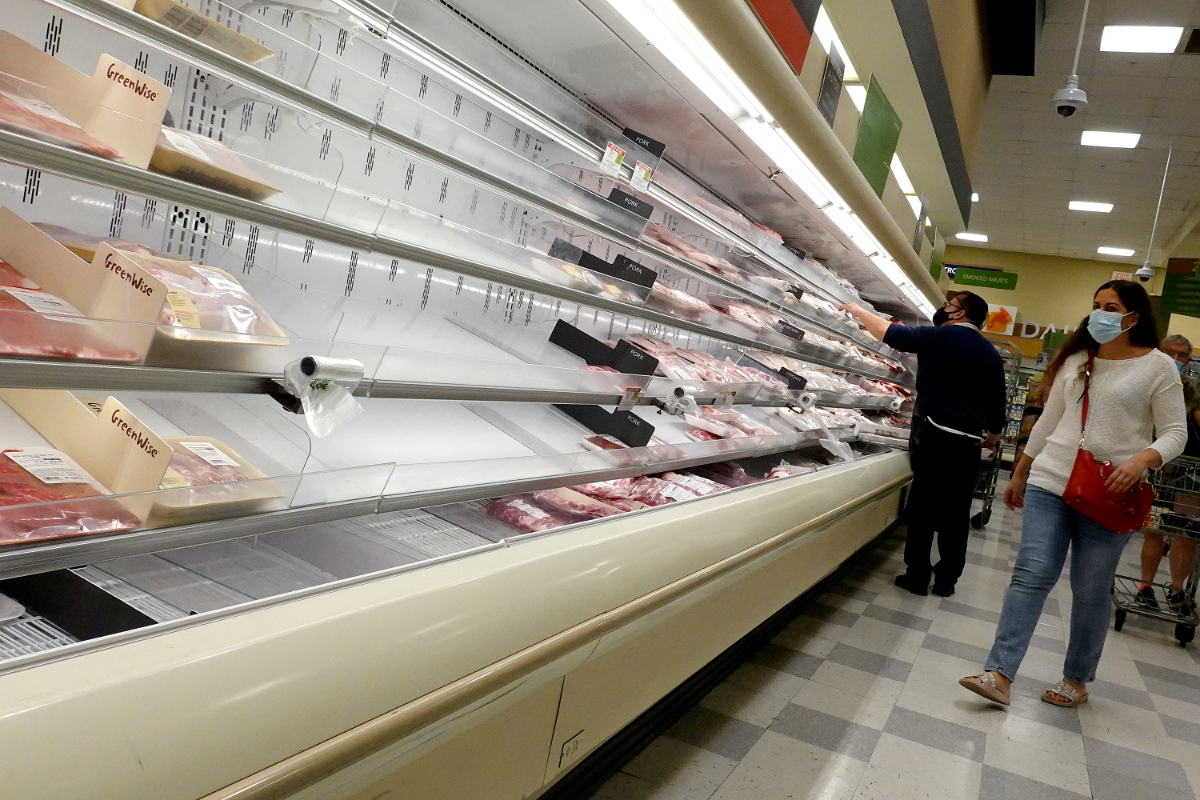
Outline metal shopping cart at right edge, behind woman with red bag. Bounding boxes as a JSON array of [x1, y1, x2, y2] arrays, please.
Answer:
[[1112, 458, 1200, 648]]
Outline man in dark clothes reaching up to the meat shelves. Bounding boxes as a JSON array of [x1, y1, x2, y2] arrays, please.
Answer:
[[845, 291, 1007, 597]]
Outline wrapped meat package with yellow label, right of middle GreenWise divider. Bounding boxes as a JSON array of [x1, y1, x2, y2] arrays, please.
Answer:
[[130, 253, 283, 337]]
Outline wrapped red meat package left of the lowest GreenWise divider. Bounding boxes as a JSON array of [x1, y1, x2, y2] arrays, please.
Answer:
[[0, 447, 142, 545]]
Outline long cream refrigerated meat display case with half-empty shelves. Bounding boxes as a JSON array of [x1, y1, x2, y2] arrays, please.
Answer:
[[0, 0, 916, 800]]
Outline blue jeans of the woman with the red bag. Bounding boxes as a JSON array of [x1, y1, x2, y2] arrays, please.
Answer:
[[984, 486, 1129, 684]]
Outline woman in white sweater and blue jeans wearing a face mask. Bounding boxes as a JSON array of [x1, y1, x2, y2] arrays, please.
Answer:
[[959, 281, 1187, 708]]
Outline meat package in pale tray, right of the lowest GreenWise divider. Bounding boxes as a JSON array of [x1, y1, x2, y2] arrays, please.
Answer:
[[146, 437, 286, 528]]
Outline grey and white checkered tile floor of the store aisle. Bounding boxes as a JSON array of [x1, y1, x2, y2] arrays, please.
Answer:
[[593, 509, 1200, 800]]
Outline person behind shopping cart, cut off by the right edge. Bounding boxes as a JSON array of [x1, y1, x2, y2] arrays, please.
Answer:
[[1138, 333, 1200, 613]]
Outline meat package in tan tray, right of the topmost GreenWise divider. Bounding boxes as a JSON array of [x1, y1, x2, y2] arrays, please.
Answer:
[[150, 127, 282, 200]]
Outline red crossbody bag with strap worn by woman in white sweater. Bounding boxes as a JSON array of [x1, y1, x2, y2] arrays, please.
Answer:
[[1062, 354, 1156, 534]]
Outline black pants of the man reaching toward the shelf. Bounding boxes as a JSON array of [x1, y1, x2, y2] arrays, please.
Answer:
[[904, 420, 982, 588]]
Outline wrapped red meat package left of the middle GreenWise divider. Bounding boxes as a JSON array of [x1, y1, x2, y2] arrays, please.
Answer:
[[0, 284, 142, 363]]
